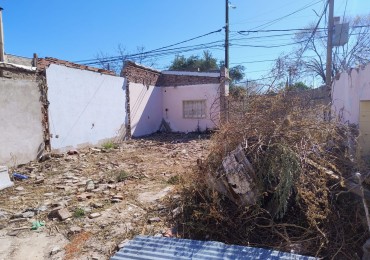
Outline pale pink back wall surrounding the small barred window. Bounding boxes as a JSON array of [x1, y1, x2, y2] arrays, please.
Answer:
[[162, 84, 220, 132]]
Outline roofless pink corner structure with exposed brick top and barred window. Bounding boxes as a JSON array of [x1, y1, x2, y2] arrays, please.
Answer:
[[122, 62, 228, 137]]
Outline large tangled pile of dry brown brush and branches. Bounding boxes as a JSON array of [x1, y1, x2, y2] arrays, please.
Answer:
[[170, 94, 369, 259]]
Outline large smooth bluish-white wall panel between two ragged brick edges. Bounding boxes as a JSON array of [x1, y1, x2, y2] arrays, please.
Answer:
[[46, 64, 126, 150]]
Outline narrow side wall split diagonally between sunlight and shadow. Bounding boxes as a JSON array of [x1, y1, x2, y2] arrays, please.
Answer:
[[129, 83, 163, 137]]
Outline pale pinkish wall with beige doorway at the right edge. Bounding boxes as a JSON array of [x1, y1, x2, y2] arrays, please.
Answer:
[[332, 64, 370, 156]]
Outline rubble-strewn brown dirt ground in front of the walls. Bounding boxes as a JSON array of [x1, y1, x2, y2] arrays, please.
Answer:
[[0, 134, 209, 260]]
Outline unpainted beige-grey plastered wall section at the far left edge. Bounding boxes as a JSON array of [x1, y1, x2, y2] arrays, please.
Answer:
[[0, 78, 44, 166]]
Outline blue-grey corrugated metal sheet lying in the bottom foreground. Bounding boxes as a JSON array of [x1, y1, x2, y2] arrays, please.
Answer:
[[111, 236, 315, 260]]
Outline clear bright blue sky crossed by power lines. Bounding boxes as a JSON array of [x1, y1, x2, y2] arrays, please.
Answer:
[[0, 0, 370, 79]]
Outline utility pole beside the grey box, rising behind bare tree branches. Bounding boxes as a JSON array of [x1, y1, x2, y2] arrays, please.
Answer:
[[326, 0, 334, 104]]
